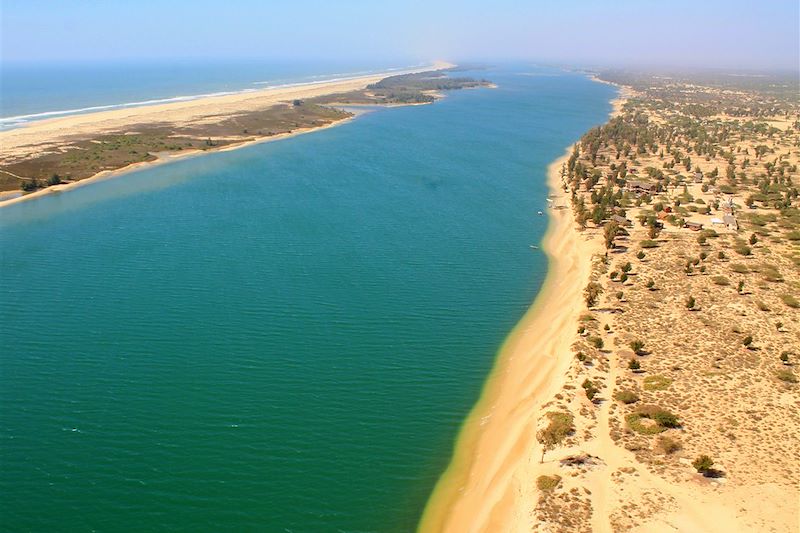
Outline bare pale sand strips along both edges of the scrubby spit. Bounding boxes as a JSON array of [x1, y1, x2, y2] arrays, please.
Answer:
[[0, 61, 455, 208]]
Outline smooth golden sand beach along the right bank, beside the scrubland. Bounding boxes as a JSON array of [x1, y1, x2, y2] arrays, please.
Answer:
[[420, 148, 601, 533]]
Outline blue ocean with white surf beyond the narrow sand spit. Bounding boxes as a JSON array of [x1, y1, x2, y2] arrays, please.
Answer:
[[0, 60, 422, 128]]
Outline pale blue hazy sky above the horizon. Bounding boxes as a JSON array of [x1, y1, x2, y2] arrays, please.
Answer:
[[0, 0, 800, 70]]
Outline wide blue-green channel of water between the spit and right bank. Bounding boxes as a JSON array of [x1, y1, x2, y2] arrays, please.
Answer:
[[0, 68, 613, 532]]
